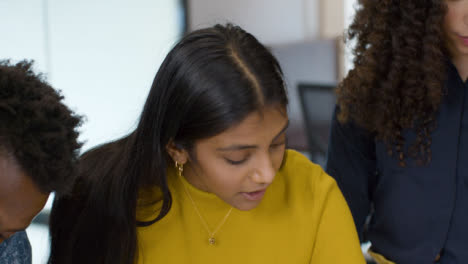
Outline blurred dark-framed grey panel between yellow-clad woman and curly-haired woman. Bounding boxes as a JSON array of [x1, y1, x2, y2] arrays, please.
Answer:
[[298, 83, 336, 165]]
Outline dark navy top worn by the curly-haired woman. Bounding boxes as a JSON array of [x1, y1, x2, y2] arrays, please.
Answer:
[[326, 64, 468, 264]]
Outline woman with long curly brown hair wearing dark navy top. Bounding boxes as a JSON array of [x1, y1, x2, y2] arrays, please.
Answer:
[[326, 0, 468, 263]]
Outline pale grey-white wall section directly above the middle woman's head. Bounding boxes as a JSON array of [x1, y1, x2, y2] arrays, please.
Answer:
[[188, 0, 318, 45]]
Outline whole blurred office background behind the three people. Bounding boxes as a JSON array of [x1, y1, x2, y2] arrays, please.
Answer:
[[0, 0, 356, 264]]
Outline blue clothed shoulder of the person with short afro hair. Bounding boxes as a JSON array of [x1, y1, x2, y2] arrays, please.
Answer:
[[0, 231, 32, 264]]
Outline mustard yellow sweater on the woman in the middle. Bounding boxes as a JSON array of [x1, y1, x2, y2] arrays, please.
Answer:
[[138, 150, 365, 264]]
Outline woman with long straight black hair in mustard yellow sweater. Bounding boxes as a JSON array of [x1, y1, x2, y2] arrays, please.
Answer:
[[49, 25, 364, 264]]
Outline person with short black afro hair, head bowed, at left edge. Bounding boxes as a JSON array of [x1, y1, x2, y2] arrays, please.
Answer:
[[0, 58, 81, 264]]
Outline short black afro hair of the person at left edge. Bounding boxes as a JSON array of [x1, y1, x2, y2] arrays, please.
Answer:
[[0, 60, 81, 193]]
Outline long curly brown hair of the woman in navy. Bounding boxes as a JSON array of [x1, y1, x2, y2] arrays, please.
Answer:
[[337, 0, 447, 166]]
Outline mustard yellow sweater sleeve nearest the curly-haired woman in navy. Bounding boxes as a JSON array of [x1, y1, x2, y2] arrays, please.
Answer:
[[311, 171, 366, 264]]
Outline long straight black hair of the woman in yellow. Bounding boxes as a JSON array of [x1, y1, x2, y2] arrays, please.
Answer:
[[49, 24, 287, 264]]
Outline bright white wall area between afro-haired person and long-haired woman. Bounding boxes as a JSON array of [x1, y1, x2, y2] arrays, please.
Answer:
[[0, 0, 182, 152]]
